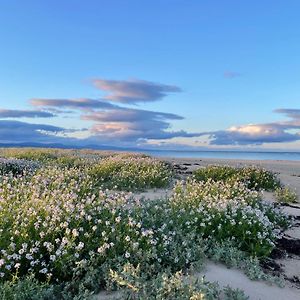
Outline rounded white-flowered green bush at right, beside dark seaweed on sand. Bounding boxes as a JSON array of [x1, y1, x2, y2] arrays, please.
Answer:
[[172, 180, 288, 256]]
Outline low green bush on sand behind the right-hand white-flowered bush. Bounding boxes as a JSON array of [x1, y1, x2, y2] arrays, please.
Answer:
[[193, 166, 280, 190]]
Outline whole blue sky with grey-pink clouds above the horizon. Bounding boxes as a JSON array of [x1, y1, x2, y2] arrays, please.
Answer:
[[0, 0, 300, 151]]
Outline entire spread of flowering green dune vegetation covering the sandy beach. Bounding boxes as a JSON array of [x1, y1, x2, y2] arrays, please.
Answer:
[[0, 149, 296, 299]]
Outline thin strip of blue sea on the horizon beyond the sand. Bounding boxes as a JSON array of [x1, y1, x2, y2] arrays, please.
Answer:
[[139, 150, 300, 161]]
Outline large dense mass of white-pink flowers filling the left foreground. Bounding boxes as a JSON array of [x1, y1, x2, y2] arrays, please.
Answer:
[[0, 167, 142, 280]]
